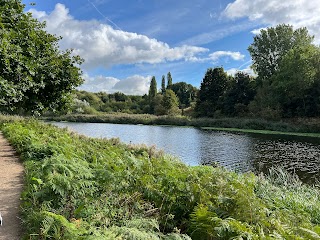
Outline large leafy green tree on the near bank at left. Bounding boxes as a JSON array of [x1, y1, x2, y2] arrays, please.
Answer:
[[0, 0, 83, 114]]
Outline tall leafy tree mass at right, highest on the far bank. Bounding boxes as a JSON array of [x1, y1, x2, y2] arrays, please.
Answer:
[[248, 24, 320, 118]]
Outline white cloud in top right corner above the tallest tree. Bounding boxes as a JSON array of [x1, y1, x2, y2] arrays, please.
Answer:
[[224, 0, 320, 42]]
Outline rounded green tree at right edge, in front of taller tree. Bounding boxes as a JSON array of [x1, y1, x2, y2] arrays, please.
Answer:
[[272, 45, 320, 117]]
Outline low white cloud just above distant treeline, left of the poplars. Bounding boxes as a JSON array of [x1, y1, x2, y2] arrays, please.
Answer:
[[79, 74, 151, 95]]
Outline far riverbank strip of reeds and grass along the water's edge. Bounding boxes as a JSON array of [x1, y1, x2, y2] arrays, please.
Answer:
[[42, 113, 320, 137]]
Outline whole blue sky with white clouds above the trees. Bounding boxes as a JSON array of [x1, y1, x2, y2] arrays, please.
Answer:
[[23, 0, 320, 95]]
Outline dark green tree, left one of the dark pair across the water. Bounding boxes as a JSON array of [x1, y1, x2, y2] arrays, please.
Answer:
[[195, 67, 228, 117]]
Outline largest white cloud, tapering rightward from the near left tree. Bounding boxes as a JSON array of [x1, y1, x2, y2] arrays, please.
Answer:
[[27, 3, 208, 68]]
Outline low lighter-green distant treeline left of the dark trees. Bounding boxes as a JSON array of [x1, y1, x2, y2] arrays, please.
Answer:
[[66, 79, 198, 115]]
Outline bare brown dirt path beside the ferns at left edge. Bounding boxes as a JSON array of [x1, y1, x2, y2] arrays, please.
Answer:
[[0, 132, 24, 240]]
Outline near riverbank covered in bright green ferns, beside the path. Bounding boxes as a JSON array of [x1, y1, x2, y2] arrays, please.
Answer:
[[0, 116, 320, 239]]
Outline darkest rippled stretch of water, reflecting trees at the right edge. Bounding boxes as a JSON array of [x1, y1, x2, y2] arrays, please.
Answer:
[[253, 136, 320, 183]]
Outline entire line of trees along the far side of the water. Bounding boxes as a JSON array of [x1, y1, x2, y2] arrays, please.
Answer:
[[63, 24, 320, 119]]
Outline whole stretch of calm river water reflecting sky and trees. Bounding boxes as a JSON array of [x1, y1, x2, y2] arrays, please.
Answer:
[[54, 122, 320, 182]]
